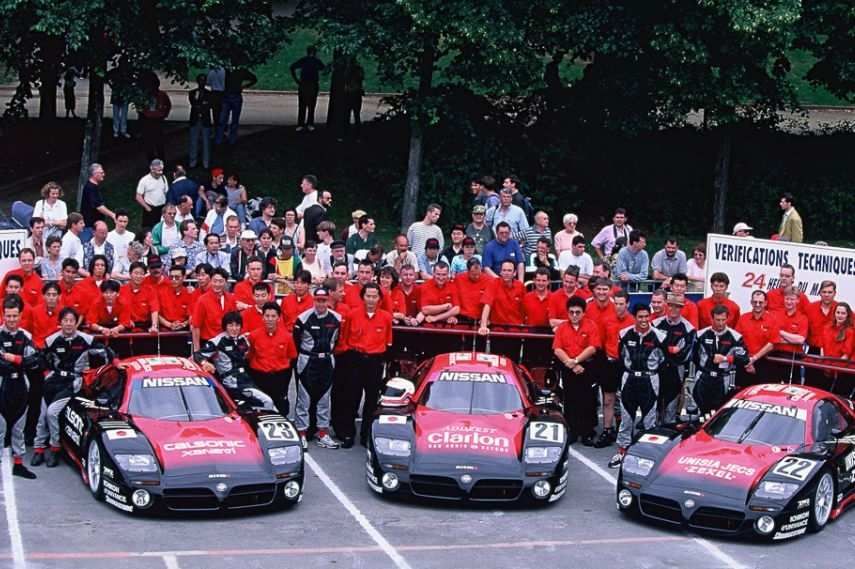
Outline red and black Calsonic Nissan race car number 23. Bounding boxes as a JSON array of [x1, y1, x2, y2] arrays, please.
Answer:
[[60, 356, 303, 512]]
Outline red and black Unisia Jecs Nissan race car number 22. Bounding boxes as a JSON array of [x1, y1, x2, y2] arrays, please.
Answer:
[[617, 384, 855, 540]]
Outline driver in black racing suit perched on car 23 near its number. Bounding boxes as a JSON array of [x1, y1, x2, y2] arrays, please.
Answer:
[[193, 308, 275, 411]]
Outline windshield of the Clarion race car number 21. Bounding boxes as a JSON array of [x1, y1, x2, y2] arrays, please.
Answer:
[[422, 372, 523, 415]]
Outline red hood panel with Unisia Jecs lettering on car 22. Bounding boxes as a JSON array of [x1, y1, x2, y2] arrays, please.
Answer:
[[651, 431, 792, 503]]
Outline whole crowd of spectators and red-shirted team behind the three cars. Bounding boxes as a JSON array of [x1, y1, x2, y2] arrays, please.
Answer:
[[0, 159, 855, 477]]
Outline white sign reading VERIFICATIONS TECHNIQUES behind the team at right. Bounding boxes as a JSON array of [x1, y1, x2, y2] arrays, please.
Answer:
[[704, 233, 855, 311]]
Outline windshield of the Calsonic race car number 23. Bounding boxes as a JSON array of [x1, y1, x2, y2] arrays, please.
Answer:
[[128, 377, 228, 421]]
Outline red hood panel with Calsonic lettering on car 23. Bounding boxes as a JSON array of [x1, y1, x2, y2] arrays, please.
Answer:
[[134, 416, 264, 474]]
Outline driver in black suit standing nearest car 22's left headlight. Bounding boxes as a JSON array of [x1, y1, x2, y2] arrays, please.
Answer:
[[609, 304, 665, 468]]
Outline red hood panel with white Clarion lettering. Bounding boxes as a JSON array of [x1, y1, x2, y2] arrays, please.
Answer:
[[414, 407, 527, 463]]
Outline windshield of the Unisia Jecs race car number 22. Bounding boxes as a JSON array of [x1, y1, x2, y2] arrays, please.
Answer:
[[706, 407, 805, 446]]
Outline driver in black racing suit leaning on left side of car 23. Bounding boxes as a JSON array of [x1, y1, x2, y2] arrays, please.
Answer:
[[30, 308, 115, 468]]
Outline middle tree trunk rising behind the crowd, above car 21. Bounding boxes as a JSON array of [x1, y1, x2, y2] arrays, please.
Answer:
[[401, 36, 436, 233]]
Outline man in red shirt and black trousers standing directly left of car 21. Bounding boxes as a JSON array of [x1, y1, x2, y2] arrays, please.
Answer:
[[346, 283, 392, 446]]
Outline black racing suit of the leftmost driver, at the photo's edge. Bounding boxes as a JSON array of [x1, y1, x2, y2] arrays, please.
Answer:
[[0, 326, 42, 458]]
